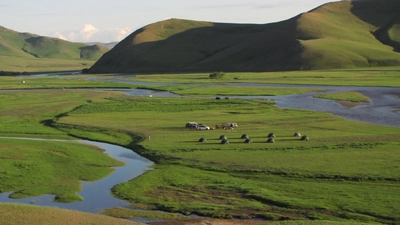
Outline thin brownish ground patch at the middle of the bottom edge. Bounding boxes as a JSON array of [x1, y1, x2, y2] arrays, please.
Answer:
[[148, 218, 265, 225]]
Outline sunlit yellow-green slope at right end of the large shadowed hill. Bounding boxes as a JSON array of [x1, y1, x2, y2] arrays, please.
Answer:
[[297, 1, 400, 69]]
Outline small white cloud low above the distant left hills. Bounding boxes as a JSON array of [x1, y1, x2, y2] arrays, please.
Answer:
[[51, 24, 133, 43]]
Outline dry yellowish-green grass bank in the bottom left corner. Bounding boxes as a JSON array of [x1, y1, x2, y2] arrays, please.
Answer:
[[0, 204, 141, 225]]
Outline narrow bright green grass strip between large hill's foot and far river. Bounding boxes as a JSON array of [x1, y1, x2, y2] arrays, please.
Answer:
[[117, 67, 400, 87]]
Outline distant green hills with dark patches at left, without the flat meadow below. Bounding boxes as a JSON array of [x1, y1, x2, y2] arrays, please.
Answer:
[[0, 26, 109, 60]]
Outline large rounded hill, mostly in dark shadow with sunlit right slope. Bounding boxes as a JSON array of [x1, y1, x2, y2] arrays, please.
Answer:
[[89, 0, 400, 73]]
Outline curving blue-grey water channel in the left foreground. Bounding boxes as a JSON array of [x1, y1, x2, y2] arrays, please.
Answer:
[[0, 138, 153, 213]]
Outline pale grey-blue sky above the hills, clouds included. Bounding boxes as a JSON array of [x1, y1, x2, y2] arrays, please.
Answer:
[[0, 0, 336, 42]]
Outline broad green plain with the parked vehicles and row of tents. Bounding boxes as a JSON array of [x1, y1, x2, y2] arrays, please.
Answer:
[[0, 71, 400, 224]]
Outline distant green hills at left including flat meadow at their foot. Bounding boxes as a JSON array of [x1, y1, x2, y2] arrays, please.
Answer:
[[0, 26, 109, 72]]
